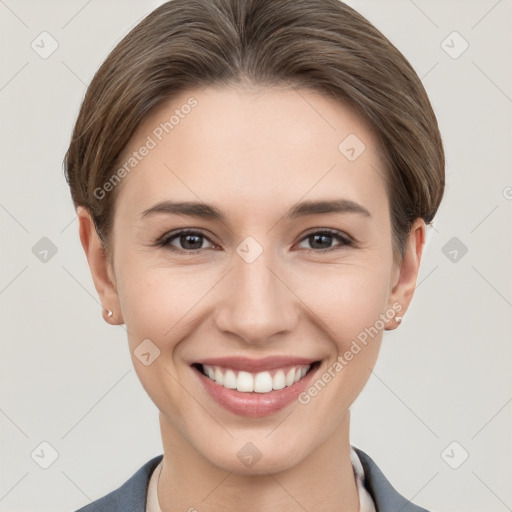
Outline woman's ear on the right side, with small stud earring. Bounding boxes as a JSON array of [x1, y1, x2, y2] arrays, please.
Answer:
[[386, 218, 426, 330]]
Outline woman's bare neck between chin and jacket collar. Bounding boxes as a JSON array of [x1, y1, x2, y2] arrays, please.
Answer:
[[158, 411, 359, 512]]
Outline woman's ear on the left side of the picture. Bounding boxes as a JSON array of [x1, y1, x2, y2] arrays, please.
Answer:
[[76, 206, 123, 325]]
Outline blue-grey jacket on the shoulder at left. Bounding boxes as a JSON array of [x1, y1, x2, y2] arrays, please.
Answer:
[[75, 455, 163, 512]]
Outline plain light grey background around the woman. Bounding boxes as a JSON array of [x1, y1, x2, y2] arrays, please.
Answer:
[[0, 0, 512, 512]]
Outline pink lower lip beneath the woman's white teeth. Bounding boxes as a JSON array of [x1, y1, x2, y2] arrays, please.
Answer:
[[192, 365, 319, 418]]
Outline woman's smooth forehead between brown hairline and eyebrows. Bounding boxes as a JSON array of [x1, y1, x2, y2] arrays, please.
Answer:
[[113, 83, 387, 218]]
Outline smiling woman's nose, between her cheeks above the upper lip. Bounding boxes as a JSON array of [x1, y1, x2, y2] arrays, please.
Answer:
[[215, 246, 300, 344]]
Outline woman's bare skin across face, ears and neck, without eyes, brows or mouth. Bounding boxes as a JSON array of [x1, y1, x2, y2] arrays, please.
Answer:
[[77, 86, 425, 512]]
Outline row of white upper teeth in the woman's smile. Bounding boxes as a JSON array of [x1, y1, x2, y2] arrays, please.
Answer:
[[203, 364, 310, 393]]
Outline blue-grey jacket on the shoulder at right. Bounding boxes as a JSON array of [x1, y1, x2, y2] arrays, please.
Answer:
[[354, 446, 429, 512]]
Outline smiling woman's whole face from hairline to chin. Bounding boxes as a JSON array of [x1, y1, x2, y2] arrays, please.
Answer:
[[79, 88, 424, 473]]
